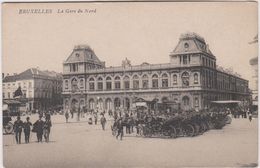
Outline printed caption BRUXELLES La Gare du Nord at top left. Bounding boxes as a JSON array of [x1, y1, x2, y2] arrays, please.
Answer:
[[19, 9, 96, 14]]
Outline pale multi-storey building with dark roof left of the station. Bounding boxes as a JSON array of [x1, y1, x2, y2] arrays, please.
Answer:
[[3, 68, 62, 111]]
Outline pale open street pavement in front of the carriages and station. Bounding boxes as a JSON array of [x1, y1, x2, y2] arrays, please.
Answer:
[[3, 115, 258, 168]]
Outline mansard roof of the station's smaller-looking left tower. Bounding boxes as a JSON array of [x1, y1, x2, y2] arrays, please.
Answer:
[[64, 45, 103, 65]]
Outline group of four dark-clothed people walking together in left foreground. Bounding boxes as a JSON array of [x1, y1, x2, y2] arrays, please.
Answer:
[[14, 113, 52, 144]]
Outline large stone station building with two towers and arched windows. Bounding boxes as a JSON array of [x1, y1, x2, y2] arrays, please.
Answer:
[[62, 33, 249, 111]]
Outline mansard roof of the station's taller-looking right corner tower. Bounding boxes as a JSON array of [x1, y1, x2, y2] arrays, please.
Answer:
[[172, 33, 215, 57]]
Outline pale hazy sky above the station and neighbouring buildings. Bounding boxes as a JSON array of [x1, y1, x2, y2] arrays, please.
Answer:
[[2, 2, 258, 87]]
